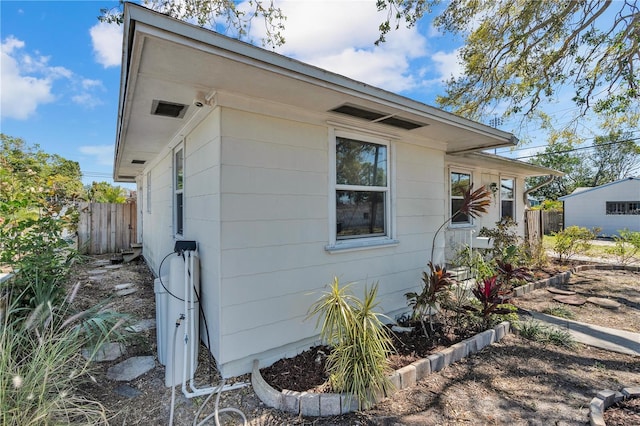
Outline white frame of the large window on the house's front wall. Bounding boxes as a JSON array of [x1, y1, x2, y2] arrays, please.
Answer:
[[325, 128, 399, 253]]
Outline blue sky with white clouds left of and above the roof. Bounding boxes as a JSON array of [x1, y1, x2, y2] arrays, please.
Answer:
[[0, 0, 576, 188]]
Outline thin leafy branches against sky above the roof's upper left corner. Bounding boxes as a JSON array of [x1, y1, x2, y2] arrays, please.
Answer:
[[98, 0, 286, 47]]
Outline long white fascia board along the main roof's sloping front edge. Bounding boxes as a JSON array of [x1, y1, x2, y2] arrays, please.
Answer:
[[125, 3, 517, 149]]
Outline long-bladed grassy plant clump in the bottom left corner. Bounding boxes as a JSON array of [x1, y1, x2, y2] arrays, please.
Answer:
[[0, 282, 126, 426]]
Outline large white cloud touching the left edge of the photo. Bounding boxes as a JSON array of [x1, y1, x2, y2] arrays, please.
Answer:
[[0, 36, 55, 120]]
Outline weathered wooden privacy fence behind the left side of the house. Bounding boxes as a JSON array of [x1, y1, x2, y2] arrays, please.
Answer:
[[78, 202, 137, 254]]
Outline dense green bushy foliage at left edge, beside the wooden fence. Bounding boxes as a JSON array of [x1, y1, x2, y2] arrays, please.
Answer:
[[0, 134, 83, 306]]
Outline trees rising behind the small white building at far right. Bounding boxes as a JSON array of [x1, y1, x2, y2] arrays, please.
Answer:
[[528, 131, 640, 200]]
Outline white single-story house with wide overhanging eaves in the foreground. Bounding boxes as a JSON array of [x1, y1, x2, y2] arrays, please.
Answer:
[[114, 3, 560, 377]]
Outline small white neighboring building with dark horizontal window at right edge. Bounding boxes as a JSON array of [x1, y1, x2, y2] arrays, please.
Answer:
[[559, 177, 640, 236]]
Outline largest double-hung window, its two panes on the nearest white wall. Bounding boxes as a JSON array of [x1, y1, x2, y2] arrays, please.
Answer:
[[335, 136, 390, 243]]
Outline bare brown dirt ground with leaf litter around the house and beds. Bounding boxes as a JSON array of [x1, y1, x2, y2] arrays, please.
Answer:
[[70, 256, 640, 425]]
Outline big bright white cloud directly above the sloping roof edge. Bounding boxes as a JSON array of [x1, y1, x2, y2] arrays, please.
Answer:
[[245, 0, 427, 92]]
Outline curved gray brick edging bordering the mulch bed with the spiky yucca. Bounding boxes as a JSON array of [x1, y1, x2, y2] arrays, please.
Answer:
[[251, 321, 511, 417]]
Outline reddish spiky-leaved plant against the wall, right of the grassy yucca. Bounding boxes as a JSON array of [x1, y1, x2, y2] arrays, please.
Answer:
[[405, 262, 454, 336]]
